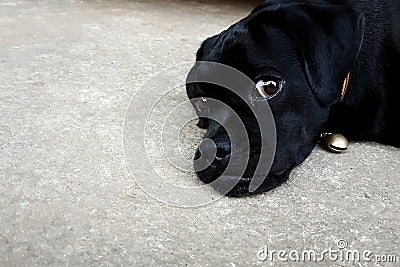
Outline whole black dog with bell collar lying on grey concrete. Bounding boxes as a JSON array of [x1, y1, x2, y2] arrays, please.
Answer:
[[187, 0, 400, 196]]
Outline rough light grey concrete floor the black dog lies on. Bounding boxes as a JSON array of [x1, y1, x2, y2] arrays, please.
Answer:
[[0, 0, 400, 266]]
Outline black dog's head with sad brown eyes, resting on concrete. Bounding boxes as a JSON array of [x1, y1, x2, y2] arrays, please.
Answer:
[[187, 1, 364, 195]]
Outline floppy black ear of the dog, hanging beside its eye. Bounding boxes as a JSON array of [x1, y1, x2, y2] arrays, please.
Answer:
[[255, 4, 364, 105]]
